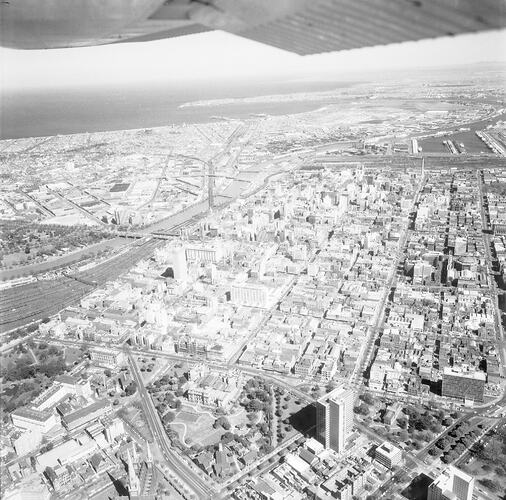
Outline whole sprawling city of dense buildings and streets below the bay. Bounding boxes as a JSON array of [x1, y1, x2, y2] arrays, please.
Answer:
[[0, 69, 506, 500]]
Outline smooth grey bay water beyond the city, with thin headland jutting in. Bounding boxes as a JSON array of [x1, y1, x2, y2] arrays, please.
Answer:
[[0, 80, 359, 139]]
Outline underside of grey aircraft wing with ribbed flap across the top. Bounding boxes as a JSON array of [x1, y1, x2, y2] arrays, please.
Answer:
[[0, 0, 506, 55]]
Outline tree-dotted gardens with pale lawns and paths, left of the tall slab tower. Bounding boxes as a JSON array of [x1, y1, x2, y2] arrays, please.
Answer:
[[148, 372, 303, 477]]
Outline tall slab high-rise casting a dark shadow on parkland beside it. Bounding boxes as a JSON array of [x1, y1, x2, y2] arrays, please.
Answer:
[[316, 386, 355, 453]]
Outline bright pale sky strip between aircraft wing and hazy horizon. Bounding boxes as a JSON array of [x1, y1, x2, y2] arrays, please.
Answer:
[[0, 29, 506, 93]]
